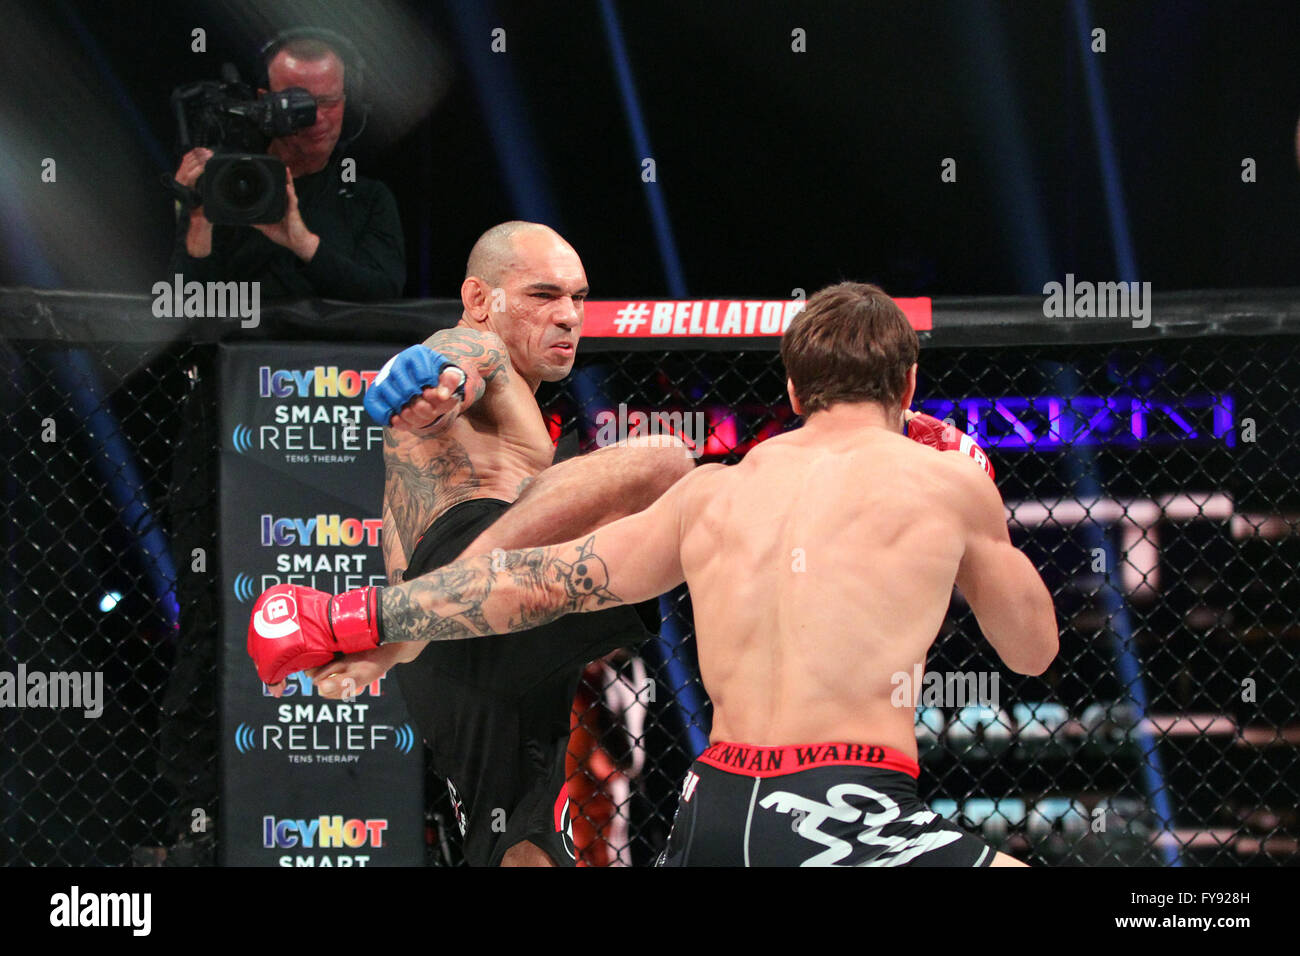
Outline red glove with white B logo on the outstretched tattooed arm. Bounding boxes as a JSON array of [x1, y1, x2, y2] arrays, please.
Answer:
[[248, 584, 381, 684]]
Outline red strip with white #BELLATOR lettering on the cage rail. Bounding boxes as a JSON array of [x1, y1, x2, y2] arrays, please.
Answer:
[[582, 298, 933, 338]]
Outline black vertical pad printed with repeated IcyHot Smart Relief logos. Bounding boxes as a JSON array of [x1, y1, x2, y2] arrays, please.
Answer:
[[220, 343, 424, 866]]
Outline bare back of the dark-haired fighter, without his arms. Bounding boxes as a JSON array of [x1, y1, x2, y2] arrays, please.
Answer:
[[681, 425, 971, 757]]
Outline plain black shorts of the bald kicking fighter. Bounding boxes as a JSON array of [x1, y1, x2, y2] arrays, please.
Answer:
[[395, 498, 659, 866]]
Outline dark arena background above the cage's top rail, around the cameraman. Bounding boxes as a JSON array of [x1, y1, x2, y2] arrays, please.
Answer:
[[0, 0, 1300, 298]]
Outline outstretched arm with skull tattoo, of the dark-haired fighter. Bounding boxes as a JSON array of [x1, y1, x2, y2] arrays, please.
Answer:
[[380, 466, 711, 644]]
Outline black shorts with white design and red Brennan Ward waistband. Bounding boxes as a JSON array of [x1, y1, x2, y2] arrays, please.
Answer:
[[658, 743, 995, 866]]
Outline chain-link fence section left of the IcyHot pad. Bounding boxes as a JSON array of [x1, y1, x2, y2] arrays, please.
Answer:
[[0, 338, 217, 866]]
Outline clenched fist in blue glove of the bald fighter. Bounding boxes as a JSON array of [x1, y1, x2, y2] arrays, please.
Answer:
[[365, 345, 468, 431]]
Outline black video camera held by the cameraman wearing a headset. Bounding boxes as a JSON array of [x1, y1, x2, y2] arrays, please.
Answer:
[[168, 64, 316, 225]]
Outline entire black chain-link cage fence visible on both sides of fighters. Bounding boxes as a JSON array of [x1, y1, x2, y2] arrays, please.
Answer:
[[0, 293, 1300, 866]]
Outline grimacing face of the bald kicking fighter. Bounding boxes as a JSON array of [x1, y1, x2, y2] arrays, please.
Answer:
[[489, 233, 588, 381]]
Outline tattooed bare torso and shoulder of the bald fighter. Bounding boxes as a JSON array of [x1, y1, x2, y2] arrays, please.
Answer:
[[384, 326, 555, 583]]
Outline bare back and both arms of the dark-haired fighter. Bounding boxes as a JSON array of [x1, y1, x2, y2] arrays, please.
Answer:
[[384, 392, 1058, 756]]
